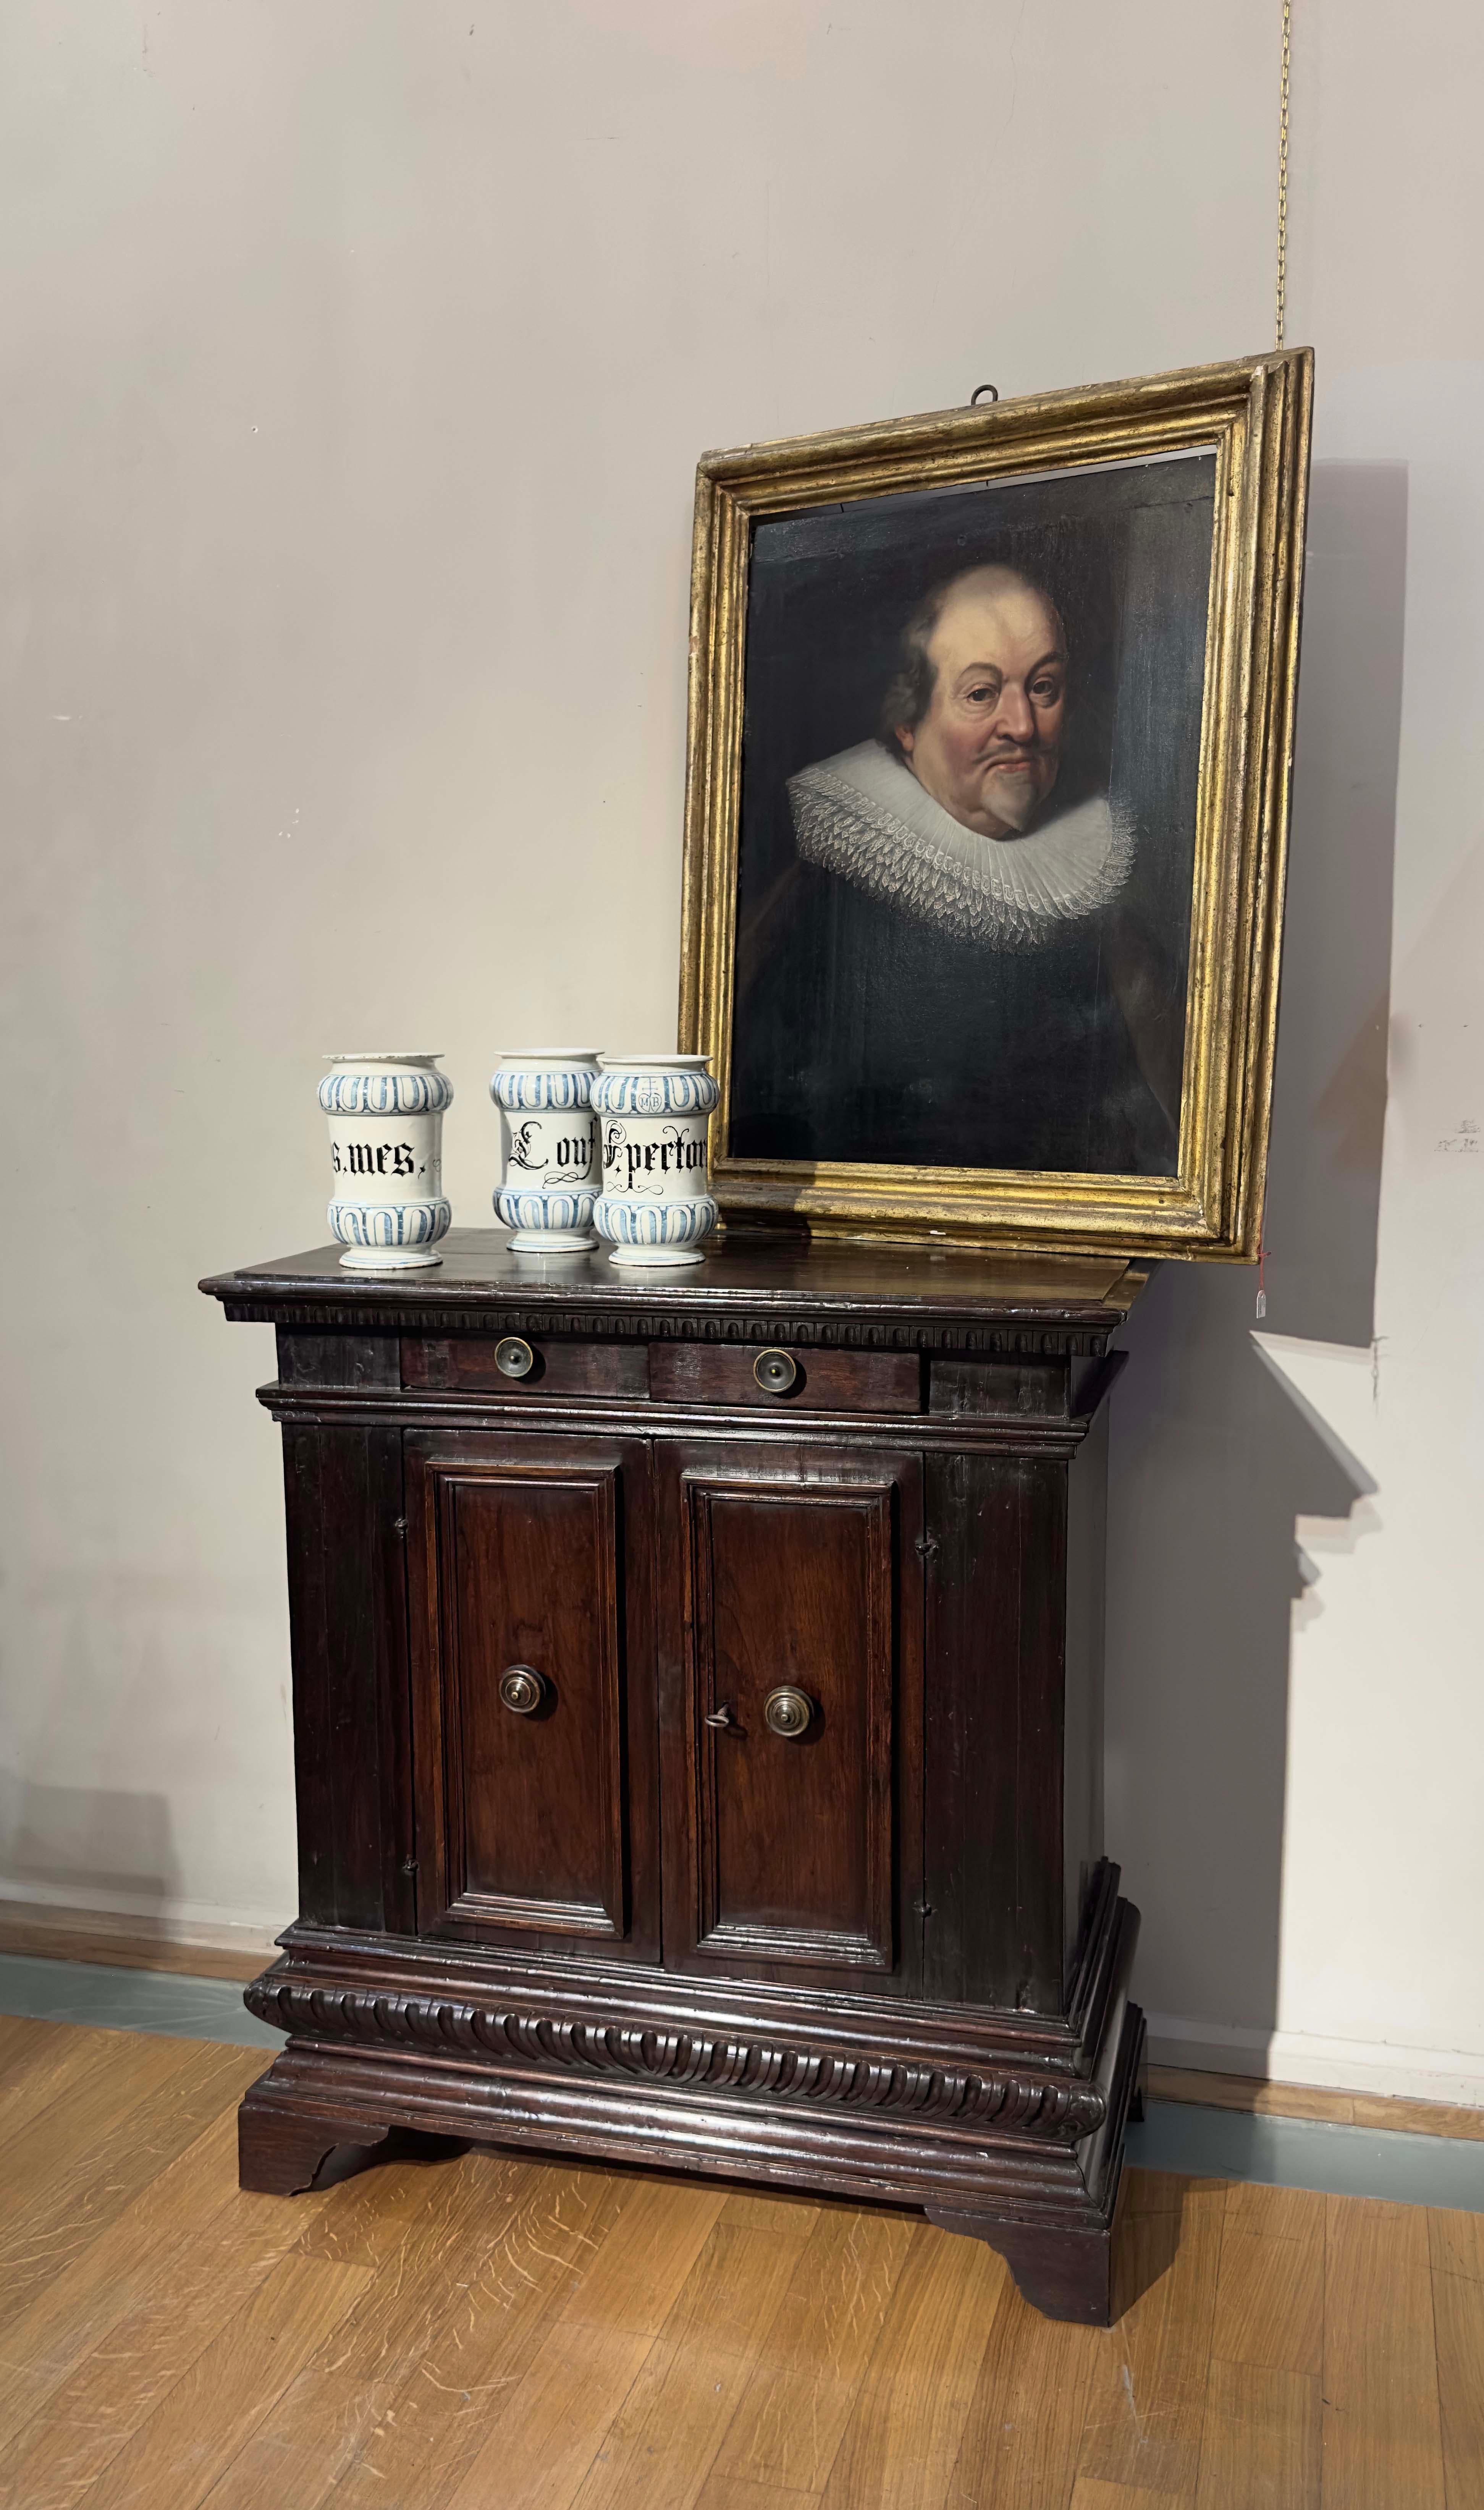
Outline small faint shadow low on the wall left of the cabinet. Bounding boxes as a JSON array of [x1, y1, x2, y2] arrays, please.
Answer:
[[0, 1772, 181, 1918]]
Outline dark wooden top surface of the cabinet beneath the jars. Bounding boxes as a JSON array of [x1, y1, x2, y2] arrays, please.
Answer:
[[201, 1230, 1145, 1333]]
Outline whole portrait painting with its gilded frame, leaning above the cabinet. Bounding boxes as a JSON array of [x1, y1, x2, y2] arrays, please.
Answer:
[[681, 351, 1311, 1257]]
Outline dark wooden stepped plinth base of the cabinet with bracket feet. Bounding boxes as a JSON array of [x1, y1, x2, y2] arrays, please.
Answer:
[[241, 1868, 1143, 2324]]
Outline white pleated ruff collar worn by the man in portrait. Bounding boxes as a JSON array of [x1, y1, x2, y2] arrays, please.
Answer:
[[789, 740, 1135, 949]]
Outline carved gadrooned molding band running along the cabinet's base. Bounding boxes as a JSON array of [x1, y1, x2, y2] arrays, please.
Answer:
[[246, 1975, 1107, 2144]]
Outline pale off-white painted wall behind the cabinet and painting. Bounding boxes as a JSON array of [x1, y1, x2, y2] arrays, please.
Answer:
[[0, 0, 1484, 2101]]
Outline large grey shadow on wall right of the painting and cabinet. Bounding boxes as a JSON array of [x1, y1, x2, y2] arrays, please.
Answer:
[[1107, 462, 1406, 2071]]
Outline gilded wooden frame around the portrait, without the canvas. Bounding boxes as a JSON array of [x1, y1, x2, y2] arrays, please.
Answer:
[[681, 349, 1313, 1260]]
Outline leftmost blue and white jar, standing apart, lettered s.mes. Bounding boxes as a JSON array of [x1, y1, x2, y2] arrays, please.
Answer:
[[319, 1054, 454, 1272]]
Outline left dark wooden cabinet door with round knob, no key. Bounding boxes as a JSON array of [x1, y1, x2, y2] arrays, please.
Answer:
[[407, 1433, 658, 1960]]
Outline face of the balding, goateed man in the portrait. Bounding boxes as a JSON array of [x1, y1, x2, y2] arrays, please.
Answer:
[[896, 567, 1067, 836]]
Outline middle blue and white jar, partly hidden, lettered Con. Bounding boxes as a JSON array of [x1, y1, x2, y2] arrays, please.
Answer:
[[490, 1047, 598, 1255]]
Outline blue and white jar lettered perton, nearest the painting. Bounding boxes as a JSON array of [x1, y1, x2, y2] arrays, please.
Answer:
[[593, 1054, 721, 1265]]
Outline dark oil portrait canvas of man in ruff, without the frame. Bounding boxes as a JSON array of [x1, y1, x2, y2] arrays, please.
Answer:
[[731, 454, 1213, 1177]]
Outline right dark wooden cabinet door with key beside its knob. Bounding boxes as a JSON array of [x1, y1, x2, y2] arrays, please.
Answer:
[[660, 1446, 921, 1993]]
